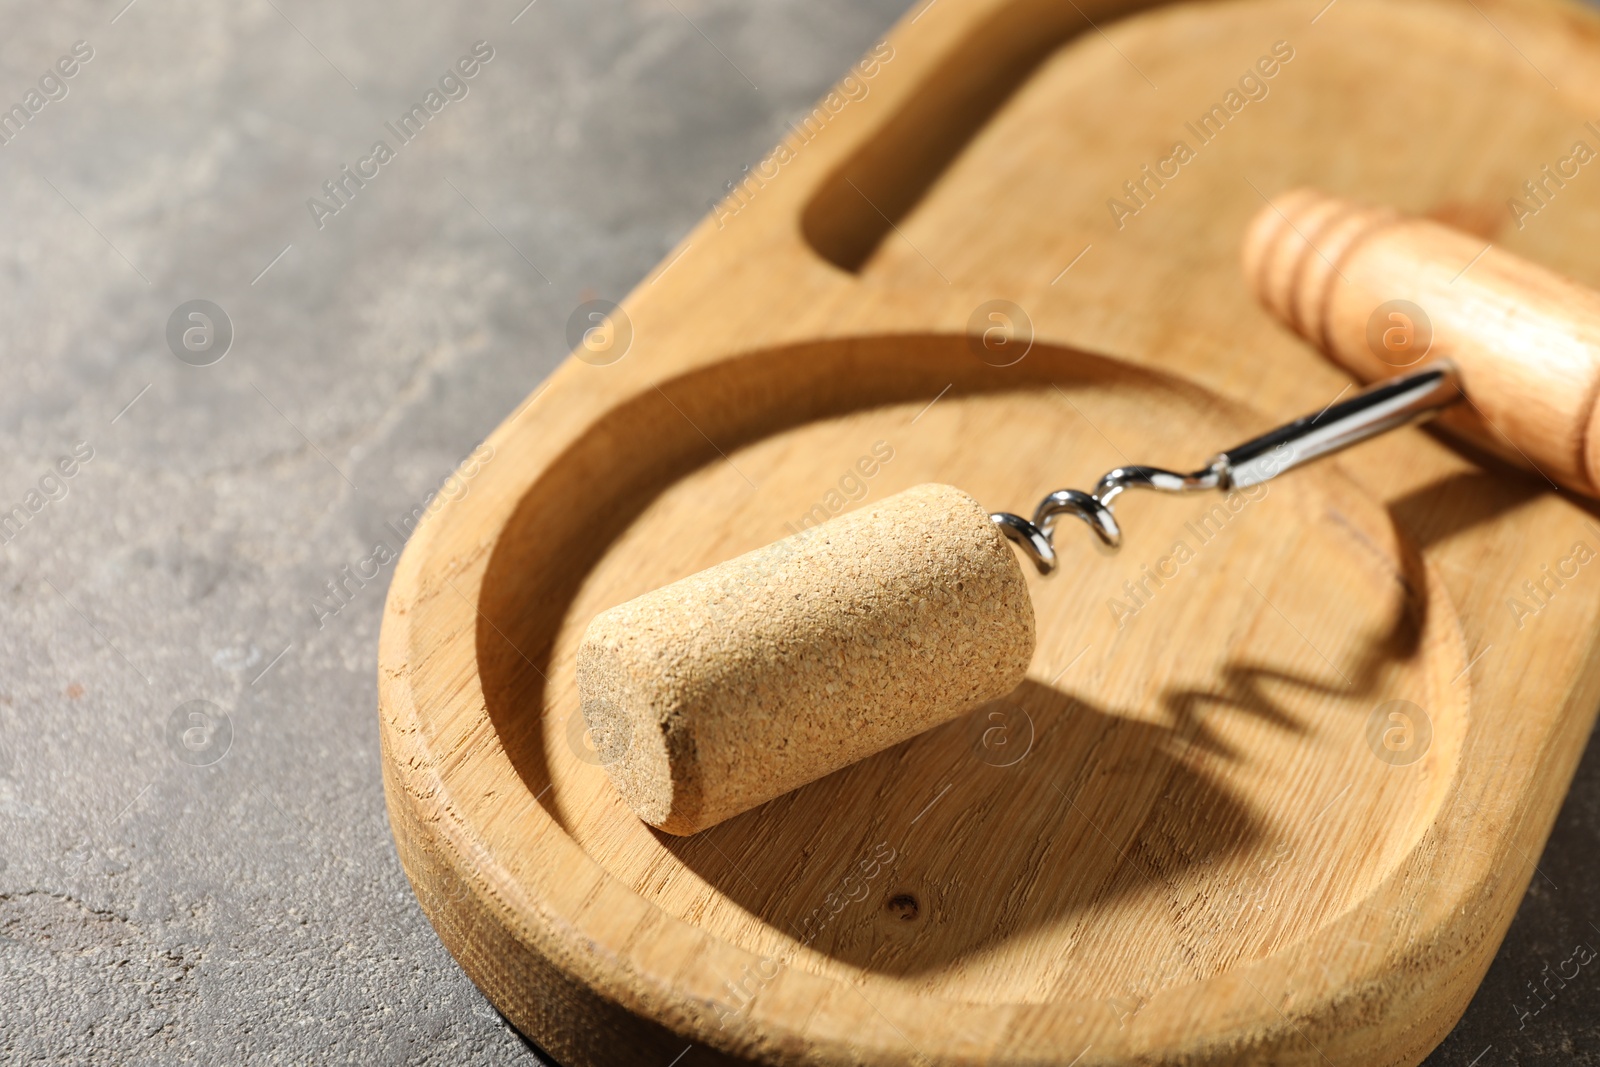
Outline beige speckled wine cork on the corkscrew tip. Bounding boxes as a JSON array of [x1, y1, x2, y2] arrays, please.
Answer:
[[578, 485, 1034, 833]]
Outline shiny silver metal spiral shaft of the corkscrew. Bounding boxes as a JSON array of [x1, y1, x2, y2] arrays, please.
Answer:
[[989, 360, 1461, 574]]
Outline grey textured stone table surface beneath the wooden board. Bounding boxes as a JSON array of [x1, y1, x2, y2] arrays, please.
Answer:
[[0, 0, 1600, 1067]]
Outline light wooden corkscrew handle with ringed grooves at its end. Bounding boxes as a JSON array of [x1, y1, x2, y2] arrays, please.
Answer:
[[1243, 189, 1600, 496]]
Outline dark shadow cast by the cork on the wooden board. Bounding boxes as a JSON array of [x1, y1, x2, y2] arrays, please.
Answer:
[[658, 681, 1267, 976]]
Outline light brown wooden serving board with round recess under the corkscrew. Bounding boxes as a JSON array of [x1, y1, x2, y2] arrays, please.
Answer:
[[379, 0, 1600, 1067]]
